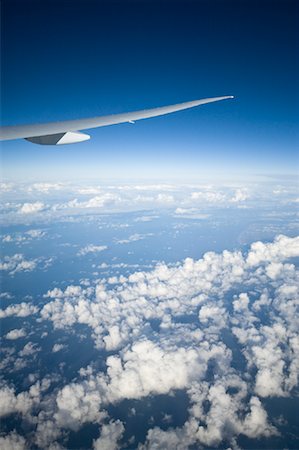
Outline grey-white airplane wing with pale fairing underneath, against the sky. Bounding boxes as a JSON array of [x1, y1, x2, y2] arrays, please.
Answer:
[[0, 95, 233, 145]]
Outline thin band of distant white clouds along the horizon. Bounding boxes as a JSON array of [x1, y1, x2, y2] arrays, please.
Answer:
[[1, 179, 297, 222]]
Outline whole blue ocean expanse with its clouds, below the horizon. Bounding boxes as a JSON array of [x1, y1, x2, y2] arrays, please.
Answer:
[[0, 178, 299, 450]]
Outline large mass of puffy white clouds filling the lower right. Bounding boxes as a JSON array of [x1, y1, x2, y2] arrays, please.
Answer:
[[4, 236, 299, 449]]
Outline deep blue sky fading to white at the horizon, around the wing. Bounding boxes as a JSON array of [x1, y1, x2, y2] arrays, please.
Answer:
[[1, 0, 299, 180]]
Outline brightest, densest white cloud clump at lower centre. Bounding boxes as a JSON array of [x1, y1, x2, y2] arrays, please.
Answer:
[[102, 340, 217, 401]]
